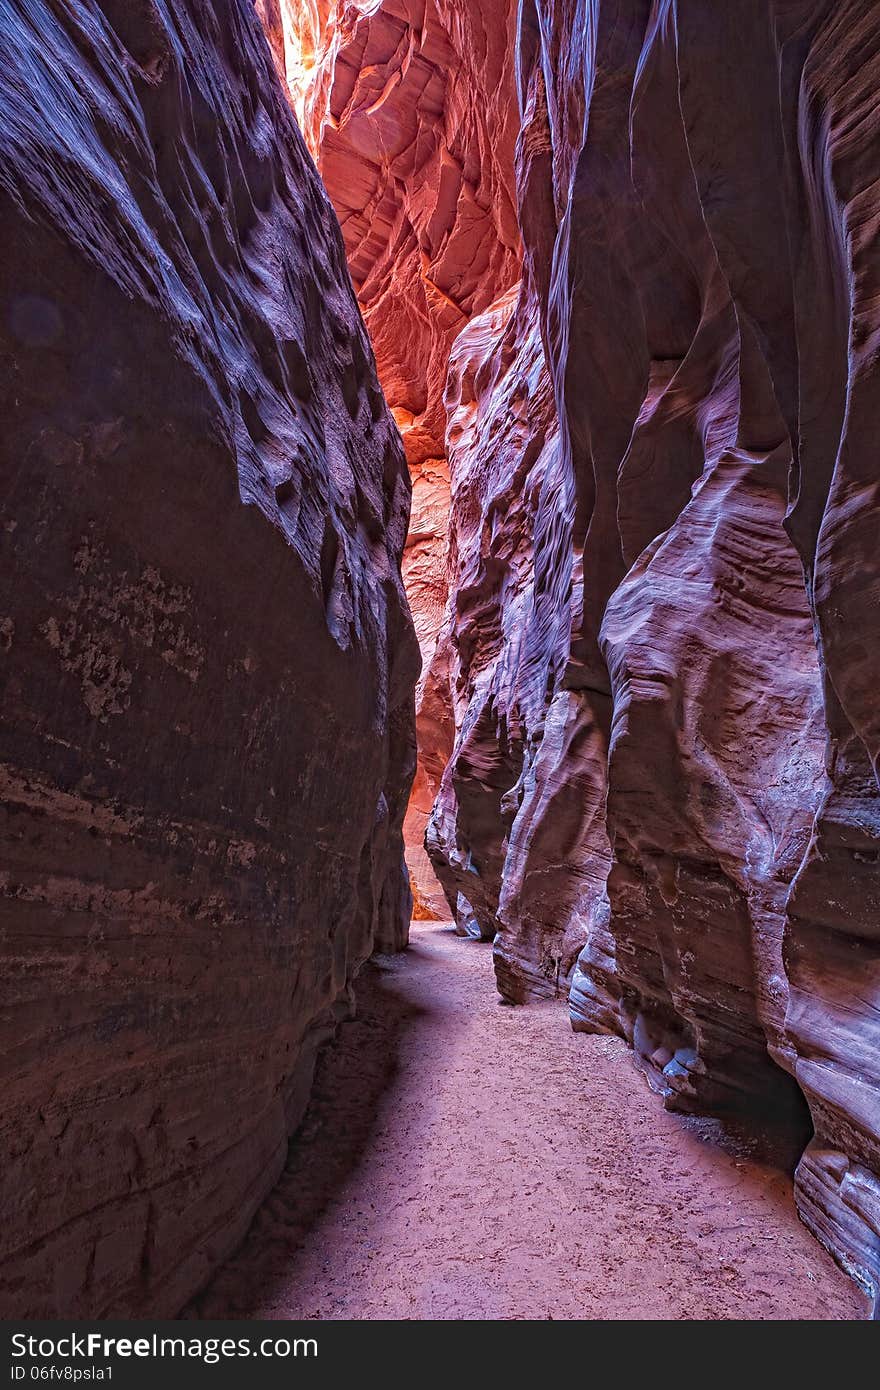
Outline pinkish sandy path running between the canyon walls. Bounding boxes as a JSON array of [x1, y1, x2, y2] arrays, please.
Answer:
[[189, 924, 867, 1319]]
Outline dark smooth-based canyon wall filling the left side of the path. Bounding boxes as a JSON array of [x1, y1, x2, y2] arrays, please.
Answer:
[[0, 0, 417, 1316]]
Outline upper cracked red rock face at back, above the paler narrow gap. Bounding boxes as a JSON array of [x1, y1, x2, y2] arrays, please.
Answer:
[[313, 0, 520, 466]]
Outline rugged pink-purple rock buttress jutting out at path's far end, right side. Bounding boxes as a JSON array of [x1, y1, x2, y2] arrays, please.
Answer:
[[428, 285, 605, 1001]]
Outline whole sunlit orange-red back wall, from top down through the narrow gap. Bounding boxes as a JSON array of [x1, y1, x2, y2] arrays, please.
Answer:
[[257, 0, 520, 916]]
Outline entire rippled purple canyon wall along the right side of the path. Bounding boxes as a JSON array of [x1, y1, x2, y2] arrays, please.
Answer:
[[419, 0, 880, 1291]]
